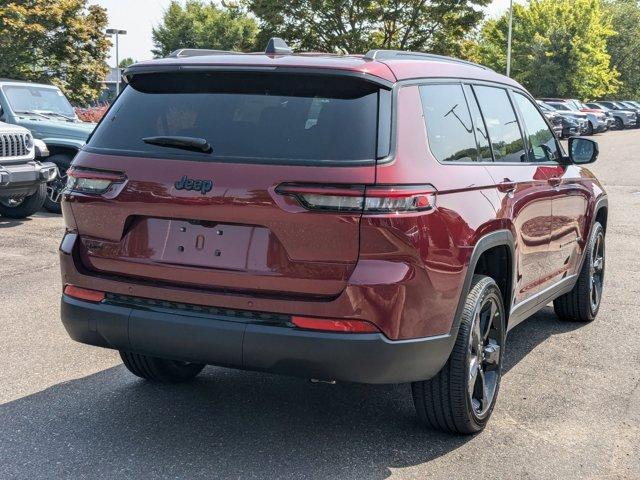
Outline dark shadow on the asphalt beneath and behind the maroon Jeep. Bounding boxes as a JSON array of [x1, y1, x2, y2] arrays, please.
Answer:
[[0, 309, 579, 479]]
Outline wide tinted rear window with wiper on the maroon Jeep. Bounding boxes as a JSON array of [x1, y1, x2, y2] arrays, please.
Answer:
[[88, 72, 379, 164]]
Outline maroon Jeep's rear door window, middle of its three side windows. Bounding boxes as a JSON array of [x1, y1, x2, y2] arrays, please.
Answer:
[[473, 85, 527, 162]]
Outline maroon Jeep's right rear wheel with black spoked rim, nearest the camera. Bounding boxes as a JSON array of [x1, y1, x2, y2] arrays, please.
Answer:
[[411, 275, 505, 434]]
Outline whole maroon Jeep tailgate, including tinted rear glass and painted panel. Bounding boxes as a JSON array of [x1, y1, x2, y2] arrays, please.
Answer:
[[66, 74, 388, 297]]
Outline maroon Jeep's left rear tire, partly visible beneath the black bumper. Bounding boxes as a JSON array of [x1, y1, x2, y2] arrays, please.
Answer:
[[120, 351, 204, 383]]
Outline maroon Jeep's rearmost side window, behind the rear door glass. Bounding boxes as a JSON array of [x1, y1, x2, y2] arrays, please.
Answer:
[[420, 84, 478, 162]]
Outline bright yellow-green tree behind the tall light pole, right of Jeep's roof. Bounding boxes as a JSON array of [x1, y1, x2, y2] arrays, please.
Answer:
[[478, 0, 619, 99]]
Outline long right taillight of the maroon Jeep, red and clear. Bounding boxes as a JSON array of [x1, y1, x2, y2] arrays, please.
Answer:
[[276, 184, 436, 214]]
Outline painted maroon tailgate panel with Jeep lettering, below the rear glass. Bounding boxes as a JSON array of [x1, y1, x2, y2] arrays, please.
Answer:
[[71, 153, 373, 296]]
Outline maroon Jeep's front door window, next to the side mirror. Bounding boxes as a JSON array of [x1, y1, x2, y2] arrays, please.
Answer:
[[515, 92, 559, 162]]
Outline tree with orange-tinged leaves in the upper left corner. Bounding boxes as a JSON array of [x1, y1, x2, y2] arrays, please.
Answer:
[[0, 0, 111, 105]]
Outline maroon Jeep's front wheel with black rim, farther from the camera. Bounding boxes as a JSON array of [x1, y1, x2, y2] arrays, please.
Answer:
[[553, 222, 605, 322]]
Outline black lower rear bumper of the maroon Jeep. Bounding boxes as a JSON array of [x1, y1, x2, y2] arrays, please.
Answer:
[[61, 295, 454, 383]]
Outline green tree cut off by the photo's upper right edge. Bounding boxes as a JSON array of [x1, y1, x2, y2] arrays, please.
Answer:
[[605, 0, 640, 99]]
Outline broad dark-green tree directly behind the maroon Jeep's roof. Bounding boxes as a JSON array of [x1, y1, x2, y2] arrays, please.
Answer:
[[244, 0, 490, 55]]
